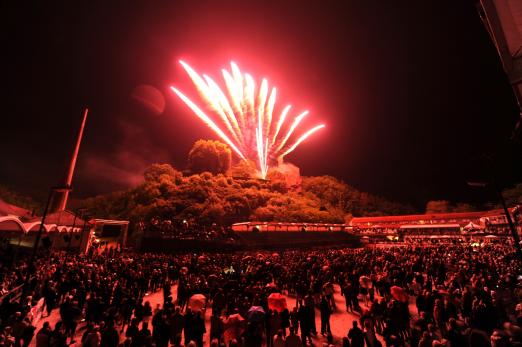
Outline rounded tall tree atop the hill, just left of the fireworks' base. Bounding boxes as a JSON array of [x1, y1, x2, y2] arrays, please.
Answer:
[[188, 140, 232, 175]]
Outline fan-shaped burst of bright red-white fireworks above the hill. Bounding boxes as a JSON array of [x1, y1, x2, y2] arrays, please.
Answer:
[[170, 61, 324, 178]]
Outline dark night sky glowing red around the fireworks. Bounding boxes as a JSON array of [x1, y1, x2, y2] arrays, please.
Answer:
[[0, 0, 522, 207]]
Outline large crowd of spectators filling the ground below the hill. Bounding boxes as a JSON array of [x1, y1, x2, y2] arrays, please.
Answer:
[[0, 244, 522, 347]]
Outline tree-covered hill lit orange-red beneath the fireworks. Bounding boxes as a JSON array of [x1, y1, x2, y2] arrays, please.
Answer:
[[83, 164, 414, 225]]
